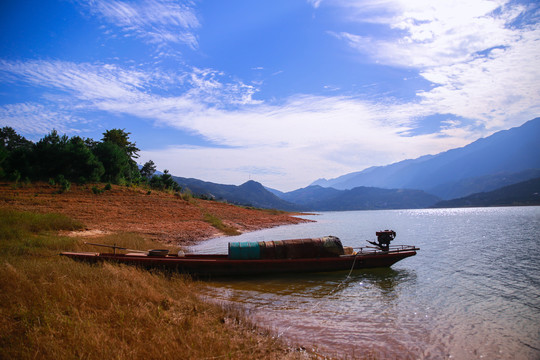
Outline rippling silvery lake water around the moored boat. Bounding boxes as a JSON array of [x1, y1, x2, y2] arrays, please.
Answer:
[[193, 207, 540, 359]]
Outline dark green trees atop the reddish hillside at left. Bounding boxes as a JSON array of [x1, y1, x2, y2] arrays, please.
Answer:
[[0, 127, 181, 191]]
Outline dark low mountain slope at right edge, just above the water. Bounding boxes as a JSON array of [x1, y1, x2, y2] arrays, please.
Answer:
[[433, 177, 540, 208]]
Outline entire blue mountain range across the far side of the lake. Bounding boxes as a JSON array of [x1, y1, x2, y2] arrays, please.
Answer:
[[170, 118, 540, 211]]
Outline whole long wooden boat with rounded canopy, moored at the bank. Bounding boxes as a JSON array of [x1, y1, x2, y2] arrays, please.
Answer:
[[61, 232, 419, 277]]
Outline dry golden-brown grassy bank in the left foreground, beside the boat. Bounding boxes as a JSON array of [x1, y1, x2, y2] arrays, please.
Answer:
[[0, 209, 310, 359]]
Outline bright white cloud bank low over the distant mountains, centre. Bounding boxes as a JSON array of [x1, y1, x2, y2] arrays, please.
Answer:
[[136, 96, 478, 190]]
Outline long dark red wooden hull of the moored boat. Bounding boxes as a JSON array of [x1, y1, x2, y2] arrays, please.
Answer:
[[61, 247, 418, 276]]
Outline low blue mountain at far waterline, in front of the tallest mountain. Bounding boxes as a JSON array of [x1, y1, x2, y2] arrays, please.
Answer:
[[283, 186, 440, 211]]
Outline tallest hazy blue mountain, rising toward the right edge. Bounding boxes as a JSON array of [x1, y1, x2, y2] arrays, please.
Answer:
[[312, 118, 540, 199]]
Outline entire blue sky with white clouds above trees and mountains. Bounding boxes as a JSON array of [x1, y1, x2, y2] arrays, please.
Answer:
[[0, 0, 540, 191]]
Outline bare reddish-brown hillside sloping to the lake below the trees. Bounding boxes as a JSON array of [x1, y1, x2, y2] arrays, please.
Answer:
[[0, 183, 306, 245]]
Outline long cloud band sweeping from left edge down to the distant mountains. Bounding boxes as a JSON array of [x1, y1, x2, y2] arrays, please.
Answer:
[[0, 61, 478, 190]]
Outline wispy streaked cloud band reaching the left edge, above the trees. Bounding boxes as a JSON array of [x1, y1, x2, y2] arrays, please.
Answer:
[[0, 60, 256, 107]]
